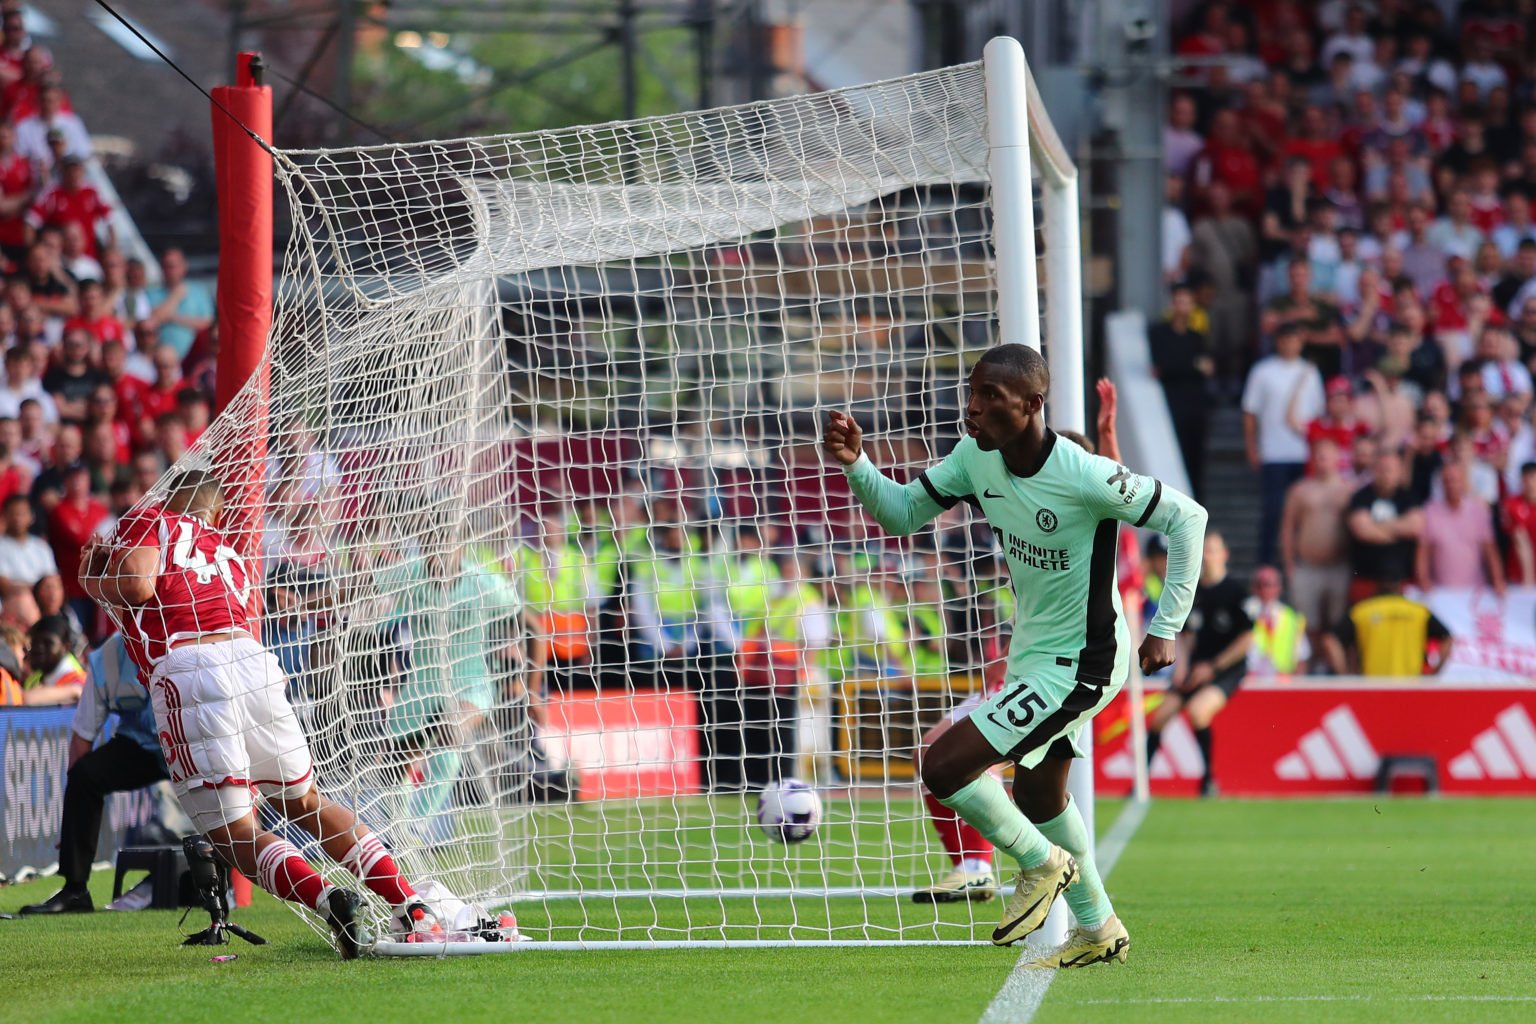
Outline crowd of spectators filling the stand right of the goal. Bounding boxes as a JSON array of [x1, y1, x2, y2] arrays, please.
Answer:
[[1150, 0, 1536, 668]]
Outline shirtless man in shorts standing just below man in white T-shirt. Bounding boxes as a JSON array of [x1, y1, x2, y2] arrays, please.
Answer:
[[1279, 434, 1353, 660]]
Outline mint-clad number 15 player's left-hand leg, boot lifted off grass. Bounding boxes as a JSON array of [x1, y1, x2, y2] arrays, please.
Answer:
[[923, 720, 1077, 946]]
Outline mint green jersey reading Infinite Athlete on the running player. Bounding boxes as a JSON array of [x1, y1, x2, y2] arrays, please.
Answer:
[[848, 430, 1206, 683]]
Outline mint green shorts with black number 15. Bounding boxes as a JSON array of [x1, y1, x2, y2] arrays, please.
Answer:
[[971, 672, 1121, 768]]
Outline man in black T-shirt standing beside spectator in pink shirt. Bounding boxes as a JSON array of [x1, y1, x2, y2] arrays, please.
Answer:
[[1347, 448, 1424, 605]]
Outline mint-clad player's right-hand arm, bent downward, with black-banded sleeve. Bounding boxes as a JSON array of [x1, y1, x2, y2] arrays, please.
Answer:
[[1081, 457, 1207, 672]]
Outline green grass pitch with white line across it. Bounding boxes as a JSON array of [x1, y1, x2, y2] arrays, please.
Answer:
[[0, 798, 1536, 1024]]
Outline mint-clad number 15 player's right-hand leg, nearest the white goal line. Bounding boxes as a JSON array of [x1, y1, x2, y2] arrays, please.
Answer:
[[1014, 757, 1130, 967]]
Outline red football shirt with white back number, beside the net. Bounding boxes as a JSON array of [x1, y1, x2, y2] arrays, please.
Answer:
[[114, 507, 253, 677]]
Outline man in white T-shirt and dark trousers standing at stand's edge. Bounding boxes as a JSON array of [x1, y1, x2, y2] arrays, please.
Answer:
[[1243, 322, 1324, 565]]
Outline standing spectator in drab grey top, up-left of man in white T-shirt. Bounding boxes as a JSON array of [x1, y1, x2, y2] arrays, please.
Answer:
[[1189, 183, 1258, 387]]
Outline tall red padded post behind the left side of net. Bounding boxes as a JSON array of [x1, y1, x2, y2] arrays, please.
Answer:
[[212, 52, 272, 906]]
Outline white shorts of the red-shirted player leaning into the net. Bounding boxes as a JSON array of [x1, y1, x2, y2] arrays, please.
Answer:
[[149, 639, 315, 832]]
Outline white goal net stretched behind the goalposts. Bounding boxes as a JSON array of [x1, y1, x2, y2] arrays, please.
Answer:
[[187, 36, 1081, 946]]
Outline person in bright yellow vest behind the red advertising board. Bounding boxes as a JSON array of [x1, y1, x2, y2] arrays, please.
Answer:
[[1322, 580, 1452, 677]]
